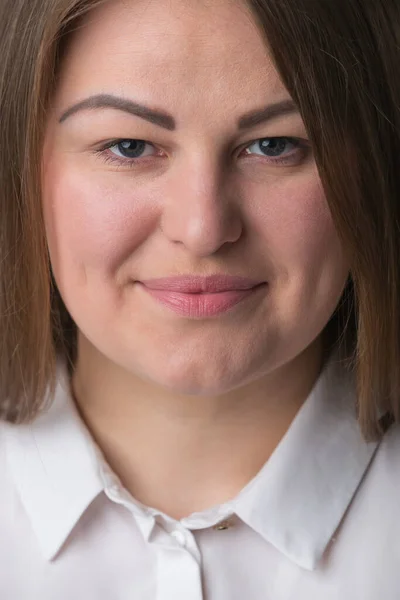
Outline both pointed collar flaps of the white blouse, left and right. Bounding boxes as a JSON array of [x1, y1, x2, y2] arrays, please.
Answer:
[[6, 346, 384, 570]]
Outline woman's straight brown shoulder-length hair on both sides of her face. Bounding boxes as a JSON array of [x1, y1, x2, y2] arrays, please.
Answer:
[[0, 0, 400, 441]]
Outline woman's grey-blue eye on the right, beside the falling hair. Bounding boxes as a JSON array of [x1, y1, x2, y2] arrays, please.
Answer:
[[244, 137, 310, 163]]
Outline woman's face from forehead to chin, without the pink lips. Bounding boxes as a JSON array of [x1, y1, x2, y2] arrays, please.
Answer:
[[43, 0, 348, 394]]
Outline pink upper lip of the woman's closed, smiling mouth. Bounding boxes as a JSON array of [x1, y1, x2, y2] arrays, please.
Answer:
[[140, 274, 266, 294]]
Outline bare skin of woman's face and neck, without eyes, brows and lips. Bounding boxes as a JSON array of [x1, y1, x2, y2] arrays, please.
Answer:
[[43, 0, 349, 518]]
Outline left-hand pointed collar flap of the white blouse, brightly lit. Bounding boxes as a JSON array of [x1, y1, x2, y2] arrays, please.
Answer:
[[6, 362, 104, 560]]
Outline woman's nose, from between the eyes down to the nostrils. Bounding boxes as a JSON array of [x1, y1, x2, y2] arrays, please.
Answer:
[[161, 155, 243, 257]]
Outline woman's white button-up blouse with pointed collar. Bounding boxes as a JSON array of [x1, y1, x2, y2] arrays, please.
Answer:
[[0, 352, 400, 600]]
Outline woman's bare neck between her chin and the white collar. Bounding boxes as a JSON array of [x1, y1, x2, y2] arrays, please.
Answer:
[[71, 335, 322, 519]]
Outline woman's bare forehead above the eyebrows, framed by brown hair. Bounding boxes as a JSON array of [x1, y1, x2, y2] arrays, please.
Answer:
[[59, 0, 287, 106]]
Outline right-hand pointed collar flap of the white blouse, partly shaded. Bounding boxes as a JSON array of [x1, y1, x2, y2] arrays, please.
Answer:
[[231, 350, 379, 570]]
